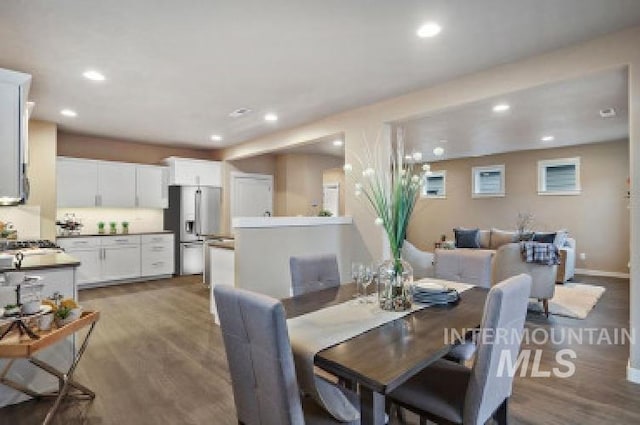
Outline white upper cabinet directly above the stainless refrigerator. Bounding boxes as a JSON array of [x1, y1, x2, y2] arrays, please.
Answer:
[[165, 157, 222, 187]]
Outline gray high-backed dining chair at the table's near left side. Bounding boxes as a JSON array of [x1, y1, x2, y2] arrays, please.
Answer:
[[213, 285, 359, 425]]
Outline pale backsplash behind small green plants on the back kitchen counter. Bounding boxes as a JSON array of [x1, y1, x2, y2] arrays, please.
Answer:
[[56, 208, 164, 234]]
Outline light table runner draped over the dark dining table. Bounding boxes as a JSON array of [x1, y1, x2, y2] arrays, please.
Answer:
[[287, 279, 473, 422]]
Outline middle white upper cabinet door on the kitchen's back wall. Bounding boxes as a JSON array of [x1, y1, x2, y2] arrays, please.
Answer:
[[98, 161, 136, 208]]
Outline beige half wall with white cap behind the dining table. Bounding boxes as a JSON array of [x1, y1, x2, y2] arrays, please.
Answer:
[[232, 217, 357, 298]]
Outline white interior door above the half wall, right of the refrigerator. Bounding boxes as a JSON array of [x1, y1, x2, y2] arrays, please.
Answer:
[[231, 174, 273, 218]]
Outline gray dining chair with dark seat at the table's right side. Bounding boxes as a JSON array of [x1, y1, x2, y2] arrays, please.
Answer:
[[389, 274, 531, 425]]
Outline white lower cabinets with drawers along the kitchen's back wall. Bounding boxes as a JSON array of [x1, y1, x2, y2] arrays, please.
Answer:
[[57, 234, 174, 288]]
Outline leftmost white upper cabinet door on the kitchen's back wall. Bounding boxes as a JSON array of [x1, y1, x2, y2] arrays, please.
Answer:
[[56, 158, 98, 208]]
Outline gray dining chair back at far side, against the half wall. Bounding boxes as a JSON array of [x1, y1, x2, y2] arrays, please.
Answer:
[[289, 254, 340, 297]]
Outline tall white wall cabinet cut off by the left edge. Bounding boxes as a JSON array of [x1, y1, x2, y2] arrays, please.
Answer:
[[0, 68, 31, 206]]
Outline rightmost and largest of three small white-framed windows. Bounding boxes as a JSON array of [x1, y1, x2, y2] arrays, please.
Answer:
[[538, 157, 580, 195]]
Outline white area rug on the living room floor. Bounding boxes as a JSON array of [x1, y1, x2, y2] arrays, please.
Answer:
[[529, 282, 605, 319]]
